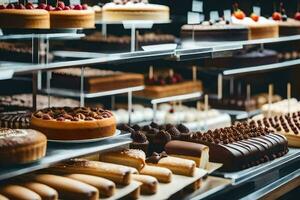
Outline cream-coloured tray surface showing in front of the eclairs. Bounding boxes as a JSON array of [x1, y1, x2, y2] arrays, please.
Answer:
[[140, 168, 207, 200]]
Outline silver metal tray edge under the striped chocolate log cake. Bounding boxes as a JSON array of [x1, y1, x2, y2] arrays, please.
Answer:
[[212, 148, 300, 185]]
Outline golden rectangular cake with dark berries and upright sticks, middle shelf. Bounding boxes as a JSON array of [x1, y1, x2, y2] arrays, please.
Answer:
[[136, 67, 202, 98]]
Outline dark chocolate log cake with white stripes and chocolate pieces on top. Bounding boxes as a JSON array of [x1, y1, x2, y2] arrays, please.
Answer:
[[189, 123, 288, 171]]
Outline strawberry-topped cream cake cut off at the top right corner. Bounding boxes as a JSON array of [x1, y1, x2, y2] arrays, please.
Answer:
[[272, 4, 300, 36]]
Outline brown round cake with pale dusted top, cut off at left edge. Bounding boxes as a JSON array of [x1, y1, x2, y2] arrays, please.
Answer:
[[0, 128, 47, 165]]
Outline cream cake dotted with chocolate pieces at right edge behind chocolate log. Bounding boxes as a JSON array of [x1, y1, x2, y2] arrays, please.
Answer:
[[250, 112, 300, 147]]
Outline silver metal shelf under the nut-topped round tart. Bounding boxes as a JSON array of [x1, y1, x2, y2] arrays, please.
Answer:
[[0, 133, 132, 182]]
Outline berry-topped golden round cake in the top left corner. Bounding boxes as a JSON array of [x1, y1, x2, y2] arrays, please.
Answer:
[[0, 3, 50, 29]]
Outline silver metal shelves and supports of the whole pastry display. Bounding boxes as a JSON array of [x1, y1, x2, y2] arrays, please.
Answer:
[[0, 33, 300, 199]]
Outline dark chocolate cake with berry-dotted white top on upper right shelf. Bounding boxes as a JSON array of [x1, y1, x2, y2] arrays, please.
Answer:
[[181, 21, 249, 42]]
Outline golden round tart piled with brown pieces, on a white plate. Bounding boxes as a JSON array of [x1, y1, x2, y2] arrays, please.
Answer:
[[31, 107, 116, 140]]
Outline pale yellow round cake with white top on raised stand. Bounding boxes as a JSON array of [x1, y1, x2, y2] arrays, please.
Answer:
[[102, 0, 170, 22]]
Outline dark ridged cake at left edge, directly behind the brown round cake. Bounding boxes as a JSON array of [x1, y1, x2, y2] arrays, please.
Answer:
[[0, 112, 31, 129]]
